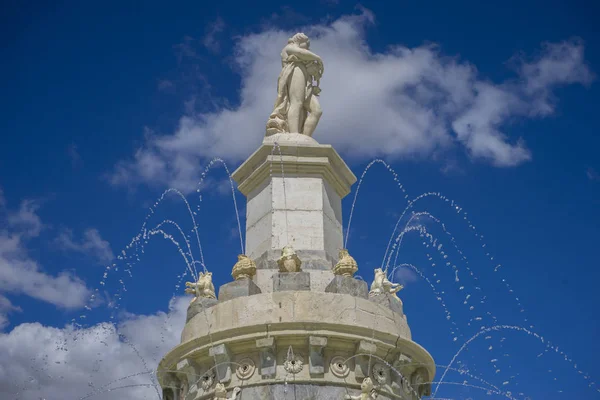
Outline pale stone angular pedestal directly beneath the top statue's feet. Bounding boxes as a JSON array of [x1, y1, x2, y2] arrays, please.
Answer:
[[232, 133, 356, 293]]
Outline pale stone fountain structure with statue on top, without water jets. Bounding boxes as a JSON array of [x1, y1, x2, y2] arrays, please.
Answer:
[[157, 34, 435, 400]]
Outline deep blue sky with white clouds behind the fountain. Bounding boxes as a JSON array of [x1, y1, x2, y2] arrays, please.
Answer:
[[0, 1, 600, 399]]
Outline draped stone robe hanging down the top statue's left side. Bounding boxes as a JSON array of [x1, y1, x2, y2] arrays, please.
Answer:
[[267, 55, 313, 135]]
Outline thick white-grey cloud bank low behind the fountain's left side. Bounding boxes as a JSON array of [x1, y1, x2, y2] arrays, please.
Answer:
[[0, 298, 189, 400]]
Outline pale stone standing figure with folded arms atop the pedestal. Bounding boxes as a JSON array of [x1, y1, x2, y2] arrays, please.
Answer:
[[267, 33, 325, 136]]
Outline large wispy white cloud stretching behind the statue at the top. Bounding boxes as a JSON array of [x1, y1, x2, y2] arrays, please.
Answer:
[[112, 10, 593, 191]]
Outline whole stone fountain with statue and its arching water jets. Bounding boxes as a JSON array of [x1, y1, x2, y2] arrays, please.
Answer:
[[10, 30, 599, 400]]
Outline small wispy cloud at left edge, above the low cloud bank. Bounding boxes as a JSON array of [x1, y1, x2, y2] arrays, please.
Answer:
[[0, 192, 89, 326]]
